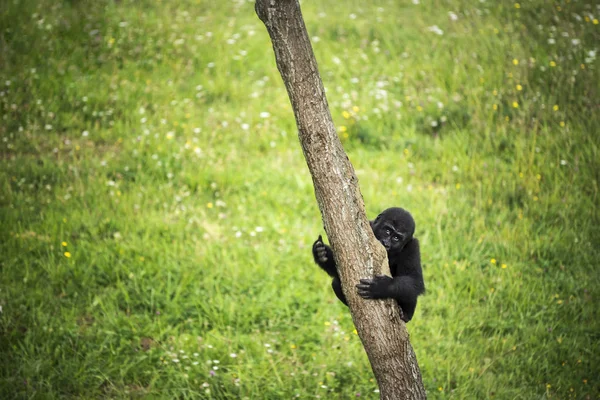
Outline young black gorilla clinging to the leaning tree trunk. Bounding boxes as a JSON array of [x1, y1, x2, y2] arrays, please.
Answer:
[[313, 207, 425, 322]]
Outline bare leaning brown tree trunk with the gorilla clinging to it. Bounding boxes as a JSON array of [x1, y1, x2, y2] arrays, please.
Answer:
[[255, 0, 426, 400]]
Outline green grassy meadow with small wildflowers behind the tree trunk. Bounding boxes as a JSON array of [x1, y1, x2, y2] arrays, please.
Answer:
[[0, 0, 600, 399]]
